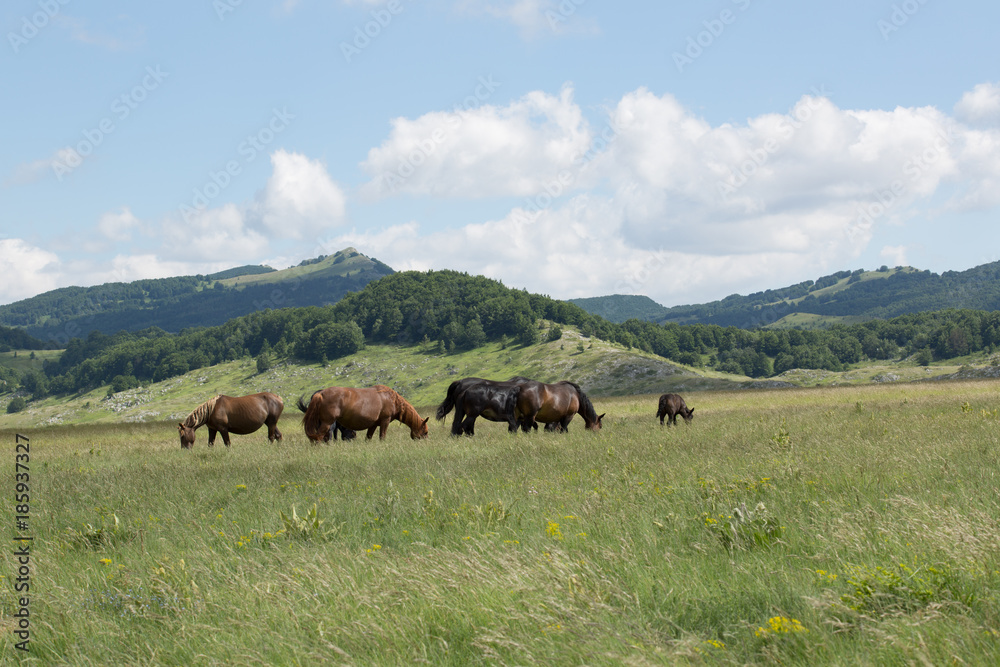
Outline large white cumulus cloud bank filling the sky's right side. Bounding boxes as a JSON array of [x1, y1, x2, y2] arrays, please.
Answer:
[[339, 81, 1000, 303]]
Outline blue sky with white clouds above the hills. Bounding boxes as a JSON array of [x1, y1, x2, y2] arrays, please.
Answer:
[[0, 0, 1000, 306]]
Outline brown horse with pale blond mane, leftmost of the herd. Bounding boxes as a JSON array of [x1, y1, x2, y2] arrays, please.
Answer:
[[177, 391, 285, 449]]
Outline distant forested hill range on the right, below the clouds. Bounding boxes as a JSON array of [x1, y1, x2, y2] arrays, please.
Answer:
[[575, 262, 1000, 329]]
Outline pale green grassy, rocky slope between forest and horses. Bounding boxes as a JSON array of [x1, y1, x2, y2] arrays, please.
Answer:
[[0, 330, 712, 428]]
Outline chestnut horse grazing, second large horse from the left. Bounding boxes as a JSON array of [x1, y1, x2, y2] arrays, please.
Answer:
[[299, 384, 430, 442]]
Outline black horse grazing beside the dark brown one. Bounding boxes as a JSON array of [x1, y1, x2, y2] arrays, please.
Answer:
[[435, 378, 521, 435]]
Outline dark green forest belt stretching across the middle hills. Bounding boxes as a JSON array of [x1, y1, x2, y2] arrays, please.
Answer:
[[4, 271, 1000, 408]]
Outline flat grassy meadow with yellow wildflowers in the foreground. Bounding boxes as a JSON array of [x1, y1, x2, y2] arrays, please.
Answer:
[[0, 381, 1000, 665]]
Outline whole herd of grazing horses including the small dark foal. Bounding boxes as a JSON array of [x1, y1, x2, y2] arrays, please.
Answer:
[[177, 376, 694, 449]]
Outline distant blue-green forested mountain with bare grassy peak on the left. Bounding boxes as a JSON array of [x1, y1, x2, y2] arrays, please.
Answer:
[[0, 248, 393, 346]]
